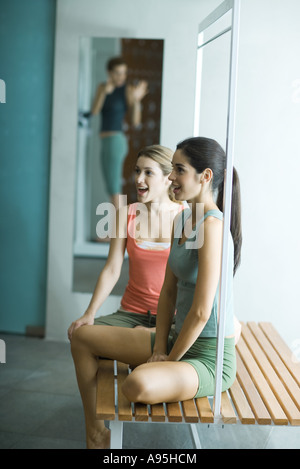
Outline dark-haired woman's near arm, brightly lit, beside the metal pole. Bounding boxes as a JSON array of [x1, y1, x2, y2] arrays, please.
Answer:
[[167, 218, 222, 361]]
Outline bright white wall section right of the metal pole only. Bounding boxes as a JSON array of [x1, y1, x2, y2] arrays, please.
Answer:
[[235, 0, 300, 346]]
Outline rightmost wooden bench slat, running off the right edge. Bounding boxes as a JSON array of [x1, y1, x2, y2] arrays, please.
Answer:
[[258, 322, 300, 386]]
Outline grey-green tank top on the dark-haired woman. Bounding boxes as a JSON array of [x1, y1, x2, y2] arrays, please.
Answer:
[[168, 208, 234, 337]]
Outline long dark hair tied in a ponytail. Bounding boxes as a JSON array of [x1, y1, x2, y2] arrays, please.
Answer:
[[177, 137, 242, 275]]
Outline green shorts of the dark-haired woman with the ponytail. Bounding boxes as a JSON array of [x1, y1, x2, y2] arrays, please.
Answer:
[[151, 332, 236, 397]]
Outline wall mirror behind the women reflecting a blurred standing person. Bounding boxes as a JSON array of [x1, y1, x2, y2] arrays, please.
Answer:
[[74, 37, 164, 257]]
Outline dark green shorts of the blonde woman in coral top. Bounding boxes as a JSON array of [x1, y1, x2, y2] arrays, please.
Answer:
[[94, 310, 156, 328]]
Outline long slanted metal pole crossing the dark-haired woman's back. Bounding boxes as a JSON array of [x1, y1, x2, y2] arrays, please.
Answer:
[[214, 0, 240, 420]]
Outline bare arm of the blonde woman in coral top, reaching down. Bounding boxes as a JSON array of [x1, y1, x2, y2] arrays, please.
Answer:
[[68, 207, 128, 339]]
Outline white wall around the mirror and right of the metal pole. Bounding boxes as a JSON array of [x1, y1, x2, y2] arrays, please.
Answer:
[[47, 0, 300, 345]]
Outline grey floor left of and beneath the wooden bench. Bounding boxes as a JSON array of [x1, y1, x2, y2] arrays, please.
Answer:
[[0, 334, 300, 449]]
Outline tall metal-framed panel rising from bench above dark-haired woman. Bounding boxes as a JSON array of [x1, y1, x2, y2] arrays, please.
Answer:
[[194, 0, 241, 419]]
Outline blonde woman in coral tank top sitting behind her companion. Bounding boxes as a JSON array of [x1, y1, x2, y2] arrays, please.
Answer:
[[68, 145, 183, 339]]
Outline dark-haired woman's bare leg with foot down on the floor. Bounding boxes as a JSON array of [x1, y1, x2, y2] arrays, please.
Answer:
[[71, 326, 151, 448]]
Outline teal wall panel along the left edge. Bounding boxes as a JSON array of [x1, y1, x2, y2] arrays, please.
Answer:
[[0, 0, 56, 334]]
